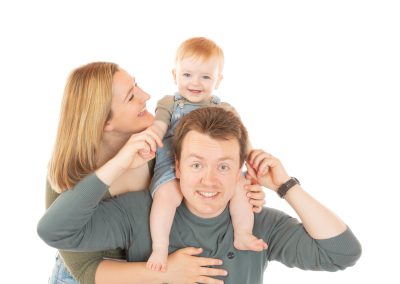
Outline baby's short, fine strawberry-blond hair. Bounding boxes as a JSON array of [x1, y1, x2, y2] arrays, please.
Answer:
[[175, 37, 224, 73]]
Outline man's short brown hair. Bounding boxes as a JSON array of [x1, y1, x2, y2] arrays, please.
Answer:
[[173, 107, 248, 165]]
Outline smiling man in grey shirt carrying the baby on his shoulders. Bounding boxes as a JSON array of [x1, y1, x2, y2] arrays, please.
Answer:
[[38, 107, 361, 283]]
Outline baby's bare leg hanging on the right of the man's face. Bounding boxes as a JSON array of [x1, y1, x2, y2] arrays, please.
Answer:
[[229, 179, 267, 251]]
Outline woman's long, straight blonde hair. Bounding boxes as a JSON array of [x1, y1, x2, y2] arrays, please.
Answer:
[[48, 62, 119, 192]]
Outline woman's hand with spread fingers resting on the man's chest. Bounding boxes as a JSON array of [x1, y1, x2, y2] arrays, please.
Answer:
[[161, 247, 227, 284]]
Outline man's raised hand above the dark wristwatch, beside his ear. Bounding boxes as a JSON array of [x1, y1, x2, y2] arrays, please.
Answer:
[[246, 150, 290, 191]]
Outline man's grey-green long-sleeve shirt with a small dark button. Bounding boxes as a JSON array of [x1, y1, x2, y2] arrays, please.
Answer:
[[38, 174, 361, 284]]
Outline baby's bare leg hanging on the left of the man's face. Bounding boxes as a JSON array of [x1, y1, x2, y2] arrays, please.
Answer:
[[146, 179, 182, 271]]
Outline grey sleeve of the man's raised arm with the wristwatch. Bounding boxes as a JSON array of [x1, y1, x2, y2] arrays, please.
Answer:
[[255, 209, 361, 271]]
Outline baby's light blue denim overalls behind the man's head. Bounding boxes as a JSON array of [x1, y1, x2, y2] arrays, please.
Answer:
[[149, 93, 221, 196]]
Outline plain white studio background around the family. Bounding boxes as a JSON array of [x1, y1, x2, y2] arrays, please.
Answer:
[[0, 0, 400, 283]]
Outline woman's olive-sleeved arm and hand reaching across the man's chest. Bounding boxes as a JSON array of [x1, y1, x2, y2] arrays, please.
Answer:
[[46, 184, 226, 284]]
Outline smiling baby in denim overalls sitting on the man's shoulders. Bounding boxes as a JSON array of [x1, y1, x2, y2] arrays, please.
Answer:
[[146, 37, 267, 271]]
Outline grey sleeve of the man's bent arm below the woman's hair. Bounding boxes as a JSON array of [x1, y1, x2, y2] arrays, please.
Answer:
[[37, 174, 151, 251]]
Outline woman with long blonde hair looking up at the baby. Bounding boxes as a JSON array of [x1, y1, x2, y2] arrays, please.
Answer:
[[46, 62, 264, 284]]
